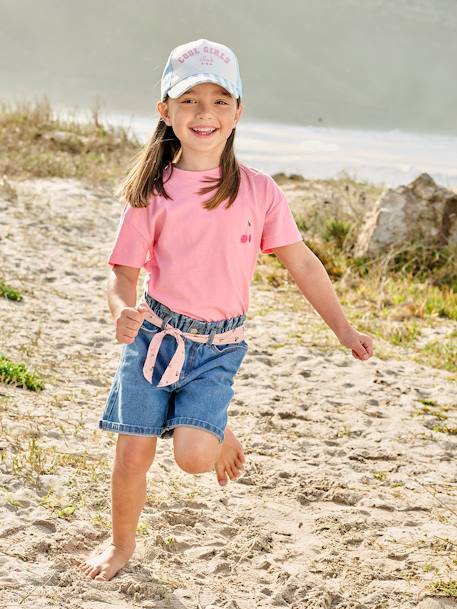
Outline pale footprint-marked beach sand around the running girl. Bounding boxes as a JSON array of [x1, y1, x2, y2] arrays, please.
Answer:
[[0, 179, 457, 609]]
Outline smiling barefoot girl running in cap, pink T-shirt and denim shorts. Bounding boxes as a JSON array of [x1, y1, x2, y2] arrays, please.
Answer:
[[76, 40, 373, 580]]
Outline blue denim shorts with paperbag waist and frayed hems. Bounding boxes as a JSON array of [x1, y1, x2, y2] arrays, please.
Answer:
[[99, 293, 248, 442]]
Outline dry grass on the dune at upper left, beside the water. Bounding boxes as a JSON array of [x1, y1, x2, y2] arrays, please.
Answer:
[[0, 97, 140, 186]]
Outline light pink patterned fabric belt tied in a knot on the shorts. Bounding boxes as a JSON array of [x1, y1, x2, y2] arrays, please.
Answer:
[[141, 301, 245, 387]]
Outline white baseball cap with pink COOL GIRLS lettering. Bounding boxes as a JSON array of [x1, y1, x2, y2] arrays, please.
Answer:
[[160, 38, 242, 101]]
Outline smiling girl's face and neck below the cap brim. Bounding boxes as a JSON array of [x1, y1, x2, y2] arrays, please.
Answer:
[[157, 83, 243, 167]]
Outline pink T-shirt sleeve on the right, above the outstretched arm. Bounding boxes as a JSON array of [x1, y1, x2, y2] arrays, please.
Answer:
[[260, 176, 303, 254]]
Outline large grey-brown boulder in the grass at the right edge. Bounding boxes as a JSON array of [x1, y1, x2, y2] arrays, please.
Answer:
[[354, 173, 457, 257]]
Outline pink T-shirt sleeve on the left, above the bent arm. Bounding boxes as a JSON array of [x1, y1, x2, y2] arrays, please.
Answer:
[[108, 203, 153, 268]]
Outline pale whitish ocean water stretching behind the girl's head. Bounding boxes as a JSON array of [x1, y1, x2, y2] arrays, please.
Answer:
[[96, 114, 457, 187]]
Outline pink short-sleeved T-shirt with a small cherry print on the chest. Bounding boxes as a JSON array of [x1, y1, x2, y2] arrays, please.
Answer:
[[108, 164, 302, 321]]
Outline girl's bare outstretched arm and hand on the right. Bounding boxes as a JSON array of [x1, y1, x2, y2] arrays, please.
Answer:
[[272, 241, 373, 360]]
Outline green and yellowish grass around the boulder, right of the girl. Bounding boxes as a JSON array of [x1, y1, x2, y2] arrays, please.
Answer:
[[254, 174, 457, 378]]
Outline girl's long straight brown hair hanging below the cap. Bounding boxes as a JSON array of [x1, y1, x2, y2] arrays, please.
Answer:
[[115, 97, 241, 209]]
